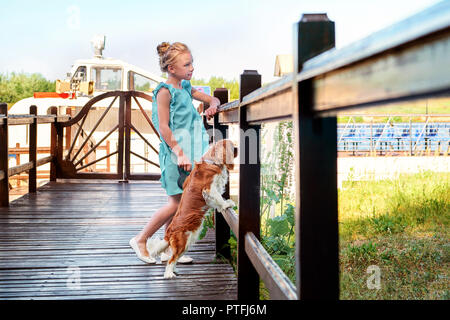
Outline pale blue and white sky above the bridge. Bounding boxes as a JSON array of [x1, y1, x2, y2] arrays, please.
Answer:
[[0, 0, 442, 83]]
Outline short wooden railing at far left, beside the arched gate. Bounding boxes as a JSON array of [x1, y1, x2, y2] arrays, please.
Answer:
[[0, 103, 69, 207]]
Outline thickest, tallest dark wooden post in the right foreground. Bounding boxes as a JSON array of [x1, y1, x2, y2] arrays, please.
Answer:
[[292, 14, 339, 300]]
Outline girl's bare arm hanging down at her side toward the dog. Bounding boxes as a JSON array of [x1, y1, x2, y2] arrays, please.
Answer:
[[156, 88, 192, 171]]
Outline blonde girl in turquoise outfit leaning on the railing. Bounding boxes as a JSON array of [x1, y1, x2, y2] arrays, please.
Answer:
[[130, 42, 220, 263]]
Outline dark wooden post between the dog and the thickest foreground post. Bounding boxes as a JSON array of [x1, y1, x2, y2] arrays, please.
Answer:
[[238, 70, 261, 300]]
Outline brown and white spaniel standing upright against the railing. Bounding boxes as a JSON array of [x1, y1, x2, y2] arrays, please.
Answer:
[[149, 140, 237, 279]]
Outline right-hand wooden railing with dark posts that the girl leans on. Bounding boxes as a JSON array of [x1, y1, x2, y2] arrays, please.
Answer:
[[209, 1, 450, 300]]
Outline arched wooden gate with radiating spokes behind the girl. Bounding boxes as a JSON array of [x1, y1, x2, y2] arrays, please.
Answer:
[[56, 91, 161, 182]]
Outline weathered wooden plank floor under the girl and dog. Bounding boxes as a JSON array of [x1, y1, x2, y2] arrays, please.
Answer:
[[0, 180, 237, 300]]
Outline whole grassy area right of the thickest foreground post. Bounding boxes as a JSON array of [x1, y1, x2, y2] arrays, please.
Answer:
[[339, 172, 450, 300]]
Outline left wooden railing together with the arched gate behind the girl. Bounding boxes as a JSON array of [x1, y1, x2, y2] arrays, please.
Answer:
[[0, 91, 161, 206]]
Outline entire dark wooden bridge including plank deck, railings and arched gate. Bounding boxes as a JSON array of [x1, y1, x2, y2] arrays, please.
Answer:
[[0, 1, 450, 300]]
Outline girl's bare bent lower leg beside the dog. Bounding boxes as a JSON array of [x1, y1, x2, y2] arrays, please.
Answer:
[[136, 194, 181, 257]]
